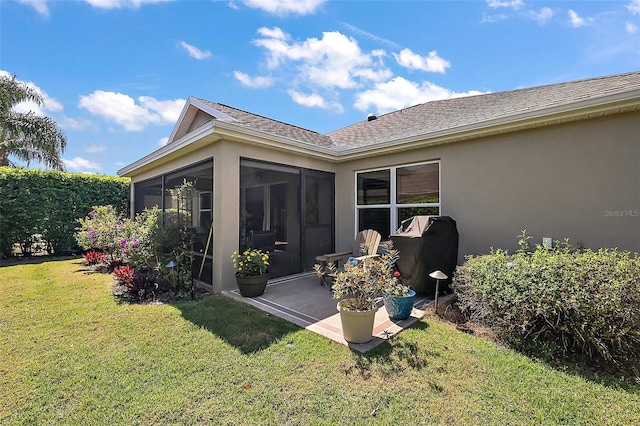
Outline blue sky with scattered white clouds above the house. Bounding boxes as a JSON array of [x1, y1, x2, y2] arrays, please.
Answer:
[[0, 0, 640, 175]]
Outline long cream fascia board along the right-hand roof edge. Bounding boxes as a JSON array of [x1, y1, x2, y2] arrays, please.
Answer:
[[334, 89, 640, 162]]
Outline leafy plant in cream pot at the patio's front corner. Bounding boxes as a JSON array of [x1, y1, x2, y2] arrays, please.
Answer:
[[331, 245, 397, 343]]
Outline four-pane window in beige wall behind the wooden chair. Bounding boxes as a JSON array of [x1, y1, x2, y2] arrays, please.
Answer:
[[356, 161, 440, 238]]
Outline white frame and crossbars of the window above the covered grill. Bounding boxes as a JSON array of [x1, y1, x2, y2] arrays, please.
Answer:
[[354, 160, 442, 235]]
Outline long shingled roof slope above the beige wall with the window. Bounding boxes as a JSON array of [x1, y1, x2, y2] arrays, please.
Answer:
[[328, 72, 640, 148]]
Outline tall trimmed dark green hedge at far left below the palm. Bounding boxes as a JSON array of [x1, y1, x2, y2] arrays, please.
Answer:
[[0, 167, 130, 257]]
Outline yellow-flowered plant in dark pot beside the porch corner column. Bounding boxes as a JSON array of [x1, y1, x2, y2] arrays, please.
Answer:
[[231, 248, 269, 297]]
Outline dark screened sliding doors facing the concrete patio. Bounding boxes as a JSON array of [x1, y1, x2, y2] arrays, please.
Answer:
[[238, 159, 334, 277]]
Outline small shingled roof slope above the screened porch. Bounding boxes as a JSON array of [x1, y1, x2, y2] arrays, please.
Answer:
[[197, 98, 331, 148]]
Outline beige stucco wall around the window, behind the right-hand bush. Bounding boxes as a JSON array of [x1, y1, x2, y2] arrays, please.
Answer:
[[336, 112, 640, 262]]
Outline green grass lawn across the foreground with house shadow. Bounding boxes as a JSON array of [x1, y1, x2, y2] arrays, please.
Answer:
[[0, 260, 640, 426]]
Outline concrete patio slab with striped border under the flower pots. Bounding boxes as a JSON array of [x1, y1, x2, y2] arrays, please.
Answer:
[[222, 272, 433, 353]]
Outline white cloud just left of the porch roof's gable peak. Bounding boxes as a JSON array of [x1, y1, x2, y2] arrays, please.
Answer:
[[79, 90, 185, 131]]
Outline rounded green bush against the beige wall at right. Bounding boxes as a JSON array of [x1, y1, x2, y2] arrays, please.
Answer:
[[452, 232, 640, 374]]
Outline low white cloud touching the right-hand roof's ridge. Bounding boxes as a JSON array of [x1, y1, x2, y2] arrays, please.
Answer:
[[353, 77, 482, 114]]
